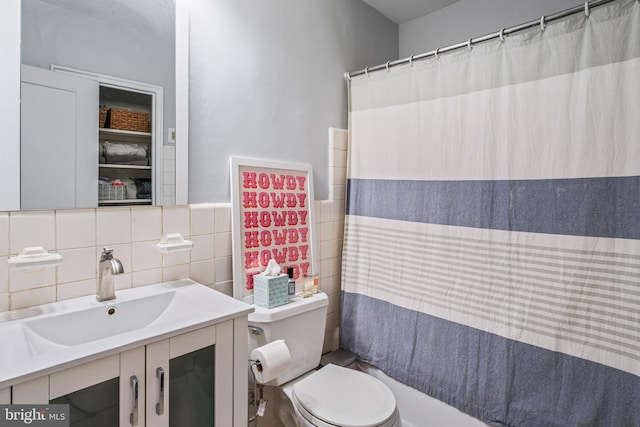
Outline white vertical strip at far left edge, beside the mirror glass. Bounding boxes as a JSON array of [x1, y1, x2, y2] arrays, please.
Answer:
[[0, 0, 20, 210]]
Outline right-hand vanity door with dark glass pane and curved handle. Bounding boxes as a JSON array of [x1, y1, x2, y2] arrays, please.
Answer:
[[147, 326, 216, 427]]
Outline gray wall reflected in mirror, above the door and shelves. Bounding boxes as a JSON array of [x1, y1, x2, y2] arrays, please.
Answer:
[[21, 0, 176, 144]]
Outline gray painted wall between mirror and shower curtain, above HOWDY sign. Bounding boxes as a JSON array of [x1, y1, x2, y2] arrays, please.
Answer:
[[189, 0, 398, 203]]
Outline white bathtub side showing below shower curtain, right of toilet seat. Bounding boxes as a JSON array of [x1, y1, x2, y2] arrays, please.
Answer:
[[358, 362, 490, 427]]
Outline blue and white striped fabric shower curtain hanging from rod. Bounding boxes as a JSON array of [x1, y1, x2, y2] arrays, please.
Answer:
[[341, 0, 640, 427]]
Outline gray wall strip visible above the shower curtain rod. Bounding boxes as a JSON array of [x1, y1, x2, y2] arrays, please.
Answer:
[[400, 0, 584, 58]]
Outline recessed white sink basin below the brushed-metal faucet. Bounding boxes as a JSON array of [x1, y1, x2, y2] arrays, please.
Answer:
[[24, 291, 176, 353]]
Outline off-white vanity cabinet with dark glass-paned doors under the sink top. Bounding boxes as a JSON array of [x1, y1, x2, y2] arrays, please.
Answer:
[[11, 320, 236, 427]]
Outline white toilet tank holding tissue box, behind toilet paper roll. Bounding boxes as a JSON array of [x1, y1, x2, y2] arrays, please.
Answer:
[[249, 292, 329, 386]]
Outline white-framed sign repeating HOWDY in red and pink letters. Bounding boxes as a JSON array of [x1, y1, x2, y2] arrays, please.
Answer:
[[231, 157, 318, 303]]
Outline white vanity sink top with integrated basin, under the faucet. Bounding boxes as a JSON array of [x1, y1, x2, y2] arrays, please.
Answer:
[[0, 279, 253, 389]]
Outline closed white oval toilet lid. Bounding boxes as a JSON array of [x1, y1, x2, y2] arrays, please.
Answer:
[[293, 364, 396, 427]]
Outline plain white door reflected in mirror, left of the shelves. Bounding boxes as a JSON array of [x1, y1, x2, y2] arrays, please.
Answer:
[[20, 65, 99, 209]]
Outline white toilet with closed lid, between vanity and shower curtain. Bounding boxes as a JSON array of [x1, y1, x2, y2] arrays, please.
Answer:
[[249, 292, 401, 427]]
